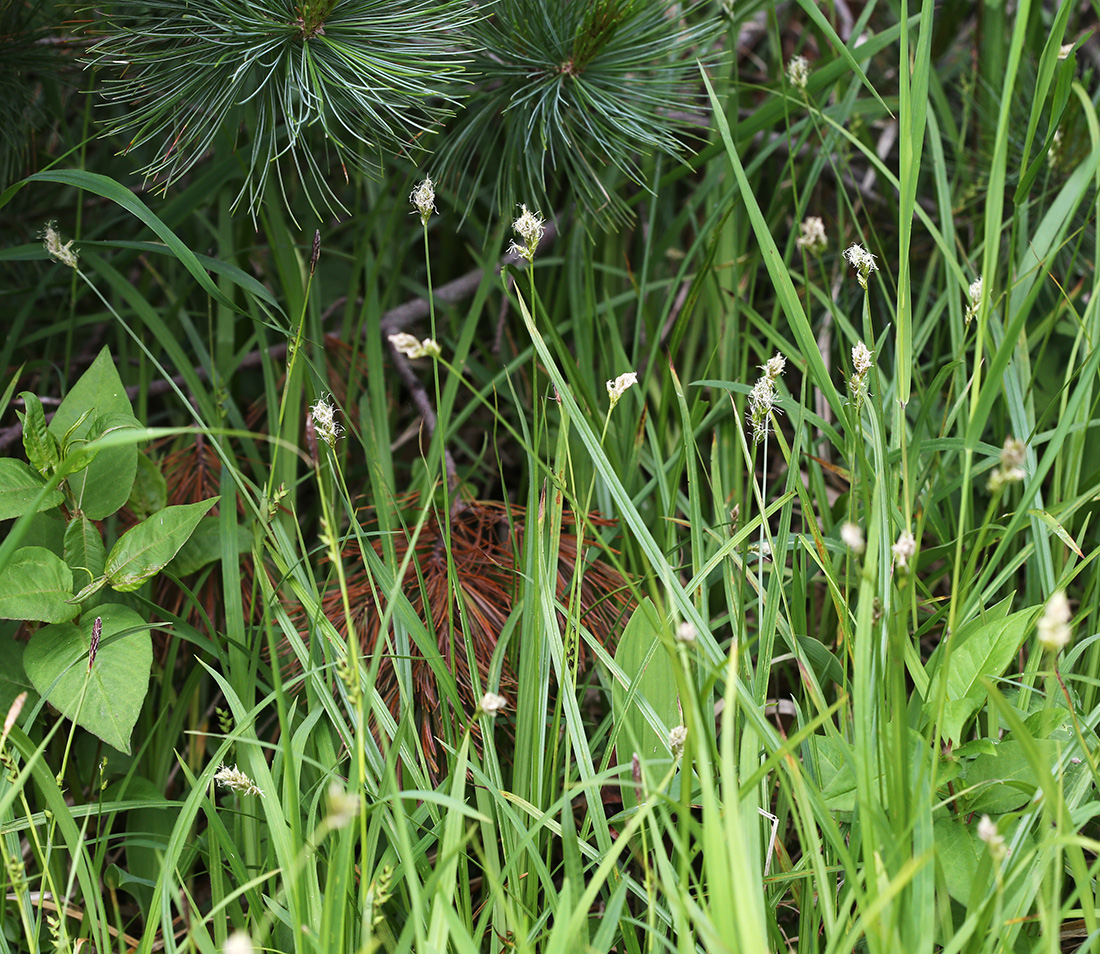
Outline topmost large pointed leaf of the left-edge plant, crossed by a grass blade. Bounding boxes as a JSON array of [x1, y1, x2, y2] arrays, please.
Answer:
[[50, 348, 138, 520]]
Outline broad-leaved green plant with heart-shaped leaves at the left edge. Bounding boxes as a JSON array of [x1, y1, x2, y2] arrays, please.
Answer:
[[0, 348, 218, 753]]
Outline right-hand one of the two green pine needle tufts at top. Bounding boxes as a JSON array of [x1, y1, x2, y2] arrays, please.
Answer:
[[440, 0, 722, 224]]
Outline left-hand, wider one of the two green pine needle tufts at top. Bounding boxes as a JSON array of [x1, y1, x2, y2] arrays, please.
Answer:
[[83, 0, 476, 213]]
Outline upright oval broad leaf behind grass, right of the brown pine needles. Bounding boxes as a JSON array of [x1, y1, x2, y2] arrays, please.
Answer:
[[612, 597, 680, 808]]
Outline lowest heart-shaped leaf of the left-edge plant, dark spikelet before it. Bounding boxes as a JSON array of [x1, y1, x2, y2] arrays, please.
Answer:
[[23, 603, 153, 755]]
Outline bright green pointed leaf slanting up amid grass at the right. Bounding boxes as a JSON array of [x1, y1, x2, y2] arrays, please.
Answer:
[[927, 604, 1035, 742]]
